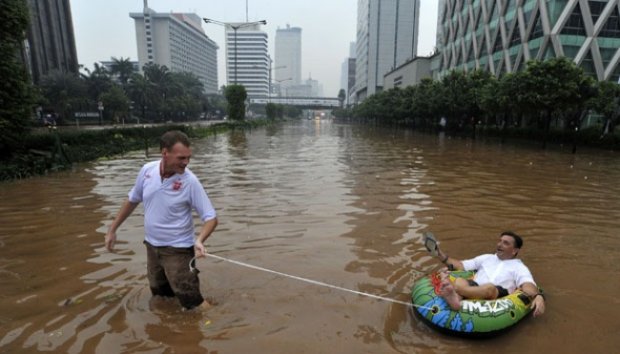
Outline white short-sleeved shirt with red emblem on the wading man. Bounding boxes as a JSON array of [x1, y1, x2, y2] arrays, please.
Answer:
[[129, 160, 216, 248]]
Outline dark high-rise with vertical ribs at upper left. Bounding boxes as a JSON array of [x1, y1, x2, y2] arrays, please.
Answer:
[[22, 0, 79, 83]]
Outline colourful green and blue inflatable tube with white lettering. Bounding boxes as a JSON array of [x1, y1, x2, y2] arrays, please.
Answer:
[[411, 271, 531, 337]]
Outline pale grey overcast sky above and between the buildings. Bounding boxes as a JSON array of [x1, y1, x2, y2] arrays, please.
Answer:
[[71, 0, 437, 96]]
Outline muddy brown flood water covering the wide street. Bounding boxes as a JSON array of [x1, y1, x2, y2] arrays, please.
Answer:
[[0, 121, 620, 353]]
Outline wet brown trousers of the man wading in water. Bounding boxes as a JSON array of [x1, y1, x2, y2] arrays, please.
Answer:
[[144, 241, 204, 309]]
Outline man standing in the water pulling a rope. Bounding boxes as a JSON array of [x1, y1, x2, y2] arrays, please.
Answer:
[[105, 131, 217, 309]]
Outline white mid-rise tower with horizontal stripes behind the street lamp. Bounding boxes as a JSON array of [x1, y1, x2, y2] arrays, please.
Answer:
[[226, 22, 271, 97]]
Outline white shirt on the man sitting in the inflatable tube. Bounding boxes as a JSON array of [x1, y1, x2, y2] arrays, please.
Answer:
[[462, 254, 536, 294]]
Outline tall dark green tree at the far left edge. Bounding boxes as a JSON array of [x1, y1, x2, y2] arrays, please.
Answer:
[[0, 0, 36, 157]]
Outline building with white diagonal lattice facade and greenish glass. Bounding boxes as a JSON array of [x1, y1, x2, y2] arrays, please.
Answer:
[[433, 0, 620, 82]]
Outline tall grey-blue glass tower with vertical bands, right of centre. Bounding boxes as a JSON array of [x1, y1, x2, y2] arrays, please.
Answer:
[[355, 0, 420, 101]]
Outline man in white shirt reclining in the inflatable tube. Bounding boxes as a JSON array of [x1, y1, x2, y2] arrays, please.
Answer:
[[437, 231, 545, 317]]
